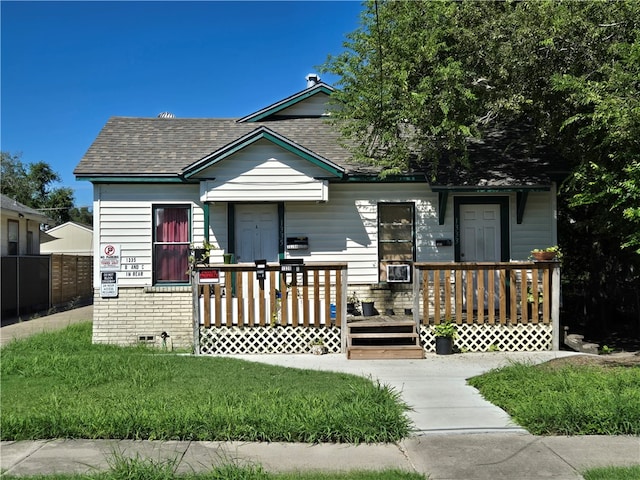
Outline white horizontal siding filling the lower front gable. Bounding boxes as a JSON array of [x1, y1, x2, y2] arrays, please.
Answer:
[[200, 140, 327, 202]]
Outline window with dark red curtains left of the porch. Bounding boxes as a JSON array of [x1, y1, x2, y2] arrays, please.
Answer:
[[153, 205, 191, 283]]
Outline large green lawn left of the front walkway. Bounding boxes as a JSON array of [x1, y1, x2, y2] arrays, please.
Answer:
[[0, 323, 409, 443]]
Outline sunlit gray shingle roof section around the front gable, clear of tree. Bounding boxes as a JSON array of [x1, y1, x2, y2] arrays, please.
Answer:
[[74, 117, 375, 178]]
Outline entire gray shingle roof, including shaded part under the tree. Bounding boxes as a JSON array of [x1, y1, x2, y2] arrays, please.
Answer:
[[74, 117, 558, 187]]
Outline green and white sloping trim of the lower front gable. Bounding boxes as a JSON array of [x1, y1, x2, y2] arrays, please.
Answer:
[[183, 126, 345, 178]]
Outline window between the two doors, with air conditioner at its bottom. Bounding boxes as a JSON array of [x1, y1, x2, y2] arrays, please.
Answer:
[[378, 203, 415, 282]]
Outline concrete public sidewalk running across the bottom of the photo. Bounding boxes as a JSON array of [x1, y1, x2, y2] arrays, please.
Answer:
[[0, 433, 640, 480]]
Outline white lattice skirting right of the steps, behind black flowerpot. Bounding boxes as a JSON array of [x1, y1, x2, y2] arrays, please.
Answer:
[[420, 323, 553, 353]]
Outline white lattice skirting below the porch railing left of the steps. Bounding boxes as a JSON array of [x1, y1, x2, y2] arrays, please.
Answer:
[[200, 326, 341, 355]]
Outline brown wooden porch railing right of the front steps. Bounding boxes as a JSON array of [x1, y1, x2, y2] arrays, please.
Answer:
[[414, 262, 560, 347]]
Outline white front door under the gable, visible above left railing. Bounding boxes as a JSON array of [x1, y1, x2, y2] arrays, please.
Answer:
[[235, 203, 278, 263]]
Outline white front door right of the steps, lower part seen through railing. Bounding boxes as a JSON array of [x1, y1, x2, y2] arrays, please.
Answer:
[[460, 204, 501, 310]]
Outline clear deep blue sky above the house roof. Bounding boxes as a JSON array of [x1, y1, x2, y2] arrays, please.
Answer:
[[0, 0, 362, 207]]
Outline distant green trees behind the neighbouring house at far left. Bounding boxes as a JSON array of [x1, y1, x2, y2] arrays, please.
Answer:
[[0, 152, 73, 223]]
